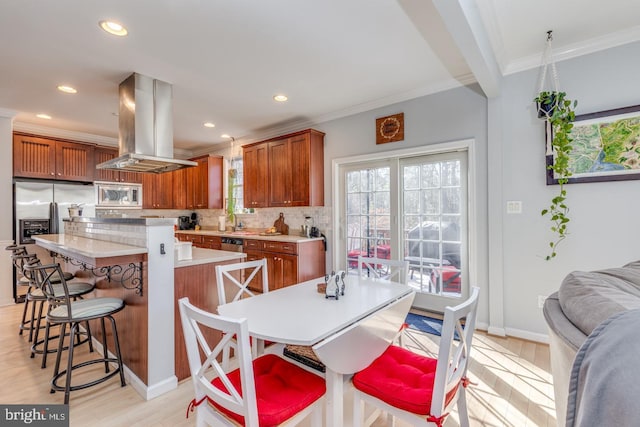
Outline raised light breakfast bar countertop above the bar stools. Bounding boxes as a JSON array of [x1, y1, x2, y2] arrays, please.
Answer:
[[33, 234, 147, 258]]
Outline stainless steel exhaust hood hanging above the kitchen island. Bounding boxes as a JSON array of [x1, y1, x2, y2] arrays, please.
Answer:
[[96, 73, 197, 173]]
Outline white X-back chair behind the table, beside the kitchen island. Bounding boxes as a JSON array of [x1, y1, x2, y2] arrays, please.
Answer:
[[216, 258, 269, 367]]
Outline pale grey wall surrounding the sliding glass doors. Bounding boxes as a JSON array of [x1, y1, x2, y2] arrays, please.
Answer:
[[314, 85, 489, 330]]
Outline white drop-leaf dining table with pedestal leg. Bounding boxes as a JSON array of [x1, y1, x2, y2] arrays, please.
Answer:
[[218, 276, 415, 427]]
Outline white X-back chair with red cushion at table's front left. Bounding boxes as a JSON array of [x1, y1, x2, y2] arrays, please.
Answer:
[[178, 298, 326, 427]]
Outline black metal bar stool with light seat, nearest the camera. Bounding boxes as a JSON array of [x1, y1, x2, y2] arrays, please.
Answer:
[[24, 264, 126, 404]]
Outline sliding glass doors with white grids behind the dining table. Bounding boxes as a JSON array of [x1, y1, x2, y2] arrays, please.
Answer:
[[340, 151, 468, 311]]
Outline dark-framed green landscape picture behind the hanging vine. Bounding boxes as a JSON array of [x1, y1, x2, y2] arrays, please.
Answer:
[[546, 105, 640, 185]]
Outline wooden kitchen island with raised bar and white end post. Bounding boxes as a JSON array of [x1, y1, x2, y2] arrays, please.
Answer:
[[35, 217, 244, 399]]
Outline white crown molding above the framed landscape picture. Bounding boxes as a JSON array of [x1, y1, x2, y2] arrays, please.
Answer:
[[504, 25, 640, 75]]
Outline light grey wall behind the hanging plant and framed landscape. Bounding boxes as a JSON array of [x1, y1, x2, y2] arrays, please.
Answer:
[[500, 43, 640, 340]]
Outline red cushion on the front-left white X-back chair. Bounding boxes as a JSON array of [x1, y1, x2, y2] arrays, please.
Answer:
[[209, 354, 326, 427]]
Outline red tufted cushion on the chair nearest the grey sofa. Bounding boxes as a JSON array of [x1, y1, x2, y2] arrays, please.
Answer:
[[353, 346, 455, 415]]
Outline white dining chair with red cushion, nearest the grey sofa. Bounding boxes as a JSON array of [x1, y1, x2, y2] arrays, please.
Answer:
[[352, 287, 479, 427]]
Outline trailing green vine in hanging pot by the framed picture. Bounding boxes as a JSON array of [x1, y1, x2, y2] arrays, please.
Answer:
[[534, 91, 578, 261]]
